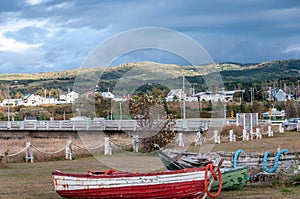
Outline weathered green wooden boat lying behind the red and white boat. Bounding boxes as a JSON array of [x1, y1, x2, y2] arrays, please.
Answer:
[[155, 145, 249, 191]]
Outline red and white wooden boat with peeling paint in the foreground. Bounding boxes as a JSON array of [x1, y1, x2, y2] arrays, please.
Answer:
[[52, 168, 221, 198]]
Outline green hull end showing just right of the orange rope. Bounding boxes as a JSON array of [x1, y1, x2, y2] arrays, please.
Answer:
[[211, 167, 249, 191]]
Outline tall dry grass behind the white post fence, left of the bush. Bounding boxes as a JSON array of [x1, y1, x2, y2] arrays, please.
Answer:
[[0, 134, 136, 166]]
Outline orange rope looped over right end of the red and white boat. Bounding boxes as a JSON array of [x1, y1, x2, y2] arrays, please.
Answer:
[[204, 164, 222, 198]]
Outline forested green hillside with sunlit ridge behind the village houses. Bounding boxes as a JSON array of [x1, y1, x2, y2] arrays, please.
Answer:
[[0, 59, 300, 97]]
